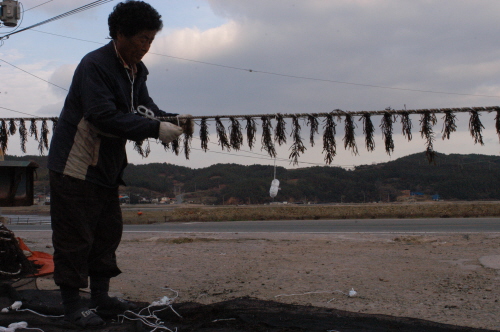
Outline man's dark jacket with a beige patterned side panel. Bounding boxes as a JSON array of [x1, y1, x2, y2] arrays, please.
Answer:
[[48, 41, 171, 187]]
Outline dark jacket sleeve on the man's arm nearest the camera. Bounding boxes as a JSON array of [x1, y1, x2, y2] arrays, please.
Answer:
[[79, 57, 159, 141]]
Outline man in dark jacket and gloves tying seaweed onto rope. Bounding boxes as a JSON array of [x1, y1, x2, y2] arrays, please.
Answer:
[[48, 0, 182, 328]]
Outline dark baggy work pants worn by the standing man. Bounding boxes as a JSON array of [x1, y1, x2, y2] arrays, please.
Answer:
[[50, 171, 123, 288]]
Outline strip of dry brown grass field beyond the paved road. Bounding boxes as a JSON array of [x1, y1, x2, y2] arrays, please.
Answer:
[[0, 201, 500, 224]]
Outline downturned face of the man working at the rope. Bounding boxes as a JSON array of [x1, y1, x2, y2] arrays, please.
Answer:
[[116, 30, 158, 64]]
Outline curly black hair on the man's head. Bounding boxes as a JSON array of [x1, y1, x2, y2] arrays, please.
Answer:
[[108, 0, 163, 39]]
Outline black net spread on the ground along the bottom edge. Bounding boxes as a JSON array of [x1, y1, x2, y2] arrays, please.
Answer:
[[0, 279, 500, 332]]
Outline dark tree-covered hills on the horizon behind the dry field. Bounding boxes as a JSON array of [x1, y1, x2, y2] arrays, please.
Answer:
[[6, 152, 500, 204]]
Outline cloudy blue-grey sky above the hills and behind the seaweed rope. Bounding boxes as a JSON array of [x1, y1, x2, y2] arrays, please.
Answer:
[[0, 0, 500, 168]]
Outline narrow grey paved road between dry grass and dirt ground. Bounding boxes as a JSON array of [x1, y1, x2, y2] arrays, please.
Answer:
[[8, 218, 500, 233]]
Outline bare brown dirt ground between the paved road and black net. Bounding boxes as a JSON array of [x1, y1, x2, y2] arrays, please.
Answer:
[[16, 232, 500, 330]]
